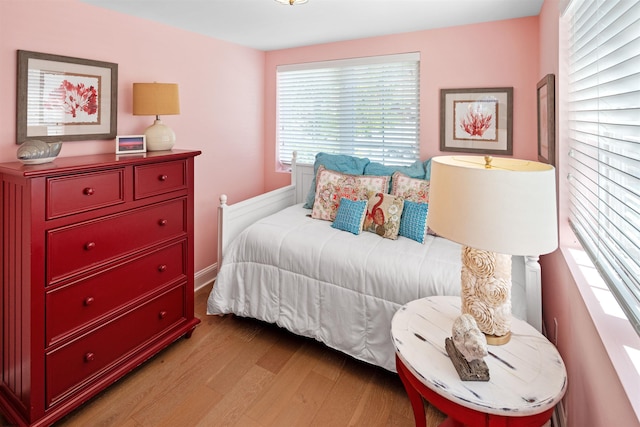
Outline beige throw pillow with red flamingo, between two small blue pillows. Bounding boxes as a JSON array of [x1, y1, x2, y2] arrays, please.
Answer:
[[363, 193, 404, 240]]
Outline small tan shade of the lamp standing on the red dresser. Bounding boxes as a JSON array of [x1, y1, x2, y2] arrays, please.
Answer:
[[133, 83, 180, 116]]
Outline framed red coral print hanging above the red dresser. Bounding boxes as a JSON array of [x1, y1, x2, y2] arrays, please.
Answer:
[[16, 50, 118, 144]]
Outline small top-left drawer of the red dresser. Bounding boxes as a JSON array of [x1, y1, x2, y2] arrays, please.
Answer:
[[46, 169, 124, 219]]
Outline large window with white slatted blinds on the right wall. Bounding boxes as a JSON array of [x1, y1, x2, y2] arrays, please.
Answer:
[[564, 0, 640, 334]]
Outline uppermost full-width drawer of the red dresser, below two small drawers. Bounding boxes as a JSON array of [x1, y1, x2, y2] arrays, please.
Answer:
[[47, 199, 187, 284]]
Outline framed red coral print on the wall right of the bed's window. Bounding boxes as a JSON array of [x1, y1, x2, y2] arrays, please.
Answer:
[[440, 87, 513, 155]]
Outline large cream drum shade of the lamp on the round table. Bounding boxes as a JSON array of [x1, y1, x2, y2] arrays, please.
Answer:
[[428, 156, 558, 256]]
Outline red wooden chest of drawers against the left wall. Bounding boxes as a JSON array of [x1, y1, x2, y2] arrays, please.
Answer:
[[0, 151, 200, 426]]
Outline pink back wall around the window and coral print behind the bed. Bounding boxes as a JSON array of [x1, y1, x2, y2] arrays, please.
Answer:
[[264, 17, 538, 189]]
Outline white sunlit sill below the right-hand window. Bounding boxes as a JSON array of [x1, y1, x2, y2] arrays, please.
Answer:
[[561, 242, 640, 420]]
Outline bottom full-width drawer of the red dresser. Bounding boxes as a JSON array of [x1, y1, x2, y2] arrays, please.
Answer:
[[45, 285, 186, 406]]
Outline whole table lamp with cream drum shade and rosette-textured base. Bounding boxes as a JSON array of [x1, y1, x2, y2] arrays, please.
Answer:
[[427, 156, 558, 344]]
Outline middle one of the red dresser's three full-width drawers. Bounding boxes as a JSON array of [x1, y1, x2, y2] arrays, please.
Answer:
[[45, 241, 187, 345]]
